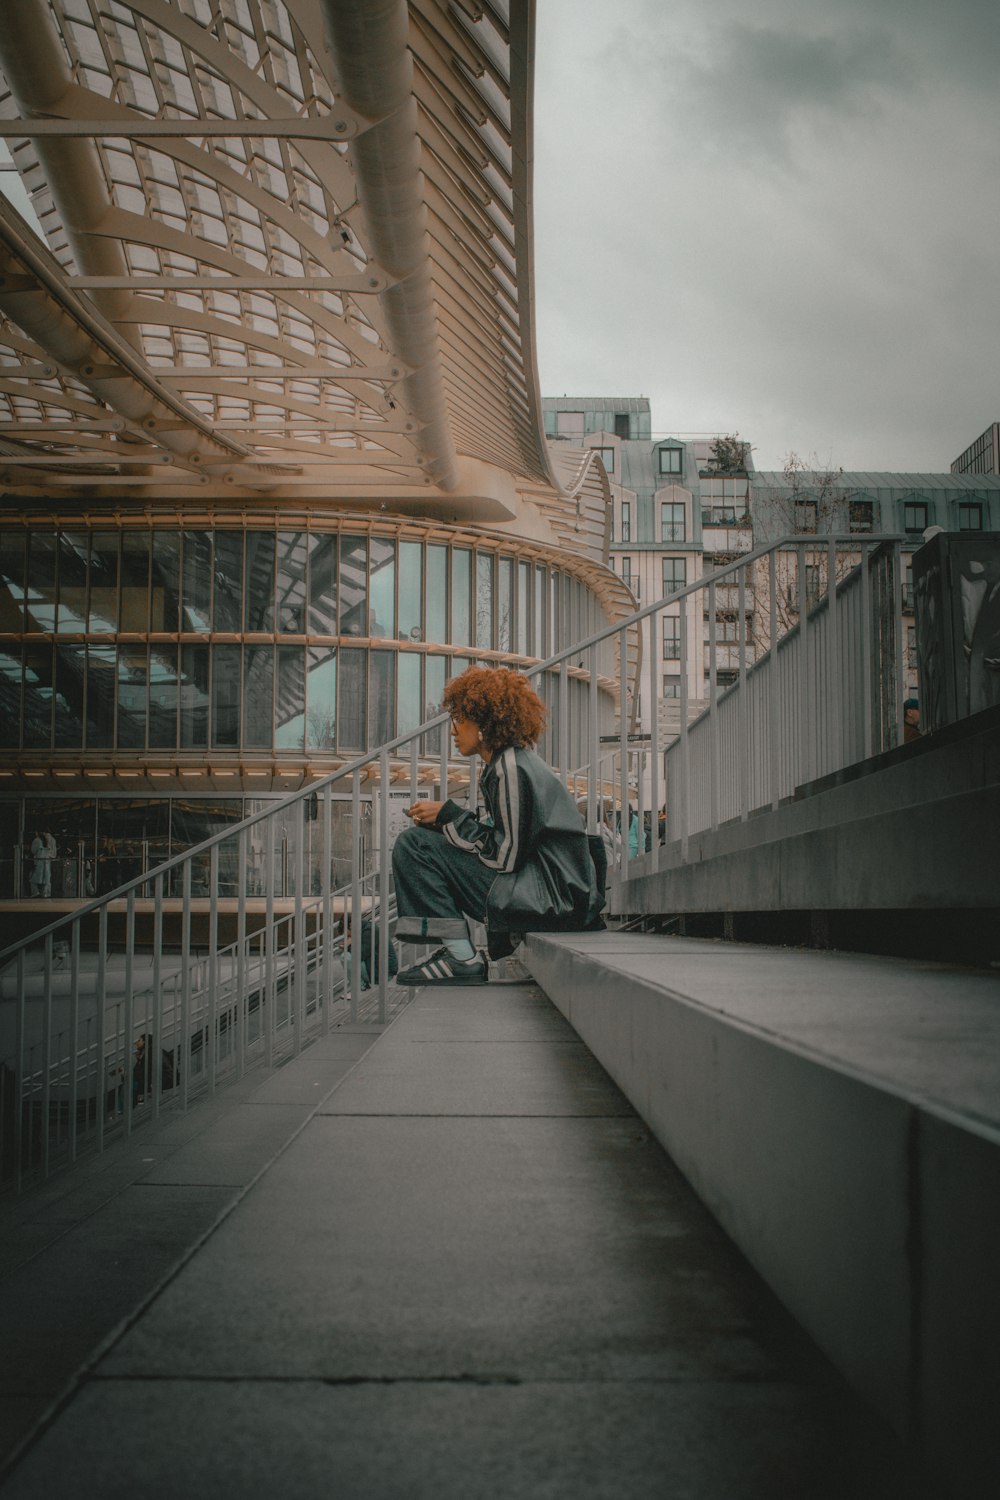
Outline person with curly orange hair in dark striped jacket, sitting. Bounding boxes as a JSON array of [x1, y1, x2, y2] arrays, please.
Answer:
[[393, 666, 604, 984]]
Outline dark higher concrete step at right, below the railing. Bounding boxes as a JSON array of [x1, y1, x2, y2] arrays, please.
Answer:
[[610, 710, 1000, 915]]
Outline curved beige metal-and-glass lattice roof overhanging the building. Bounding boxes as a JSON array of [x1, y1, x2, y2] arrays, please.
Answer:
[[0, 0, 558, 509]]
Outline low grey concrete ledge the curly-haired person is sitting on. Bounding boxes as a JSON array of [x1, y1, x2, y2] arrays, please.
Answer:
[[525, 933, 1000, 1500]]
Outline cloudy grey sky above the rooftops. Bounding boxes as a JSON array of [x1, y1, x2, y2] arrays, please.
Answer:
[[535, 0, 1000, 471]]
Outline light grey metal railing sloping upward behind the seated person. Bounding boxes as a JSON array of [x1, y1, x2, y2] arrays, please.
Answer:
[[0, 536, 903, 1188]]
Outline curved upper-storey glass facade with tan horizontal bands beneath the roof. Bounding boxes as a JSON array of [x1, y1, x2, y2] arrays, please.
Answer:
[[0, 524, 603, 756]]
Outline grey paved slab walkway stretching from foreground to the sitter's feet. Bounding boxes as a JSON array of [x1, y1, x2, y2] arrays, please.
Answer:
[[0, 983, 919, 1500]]
